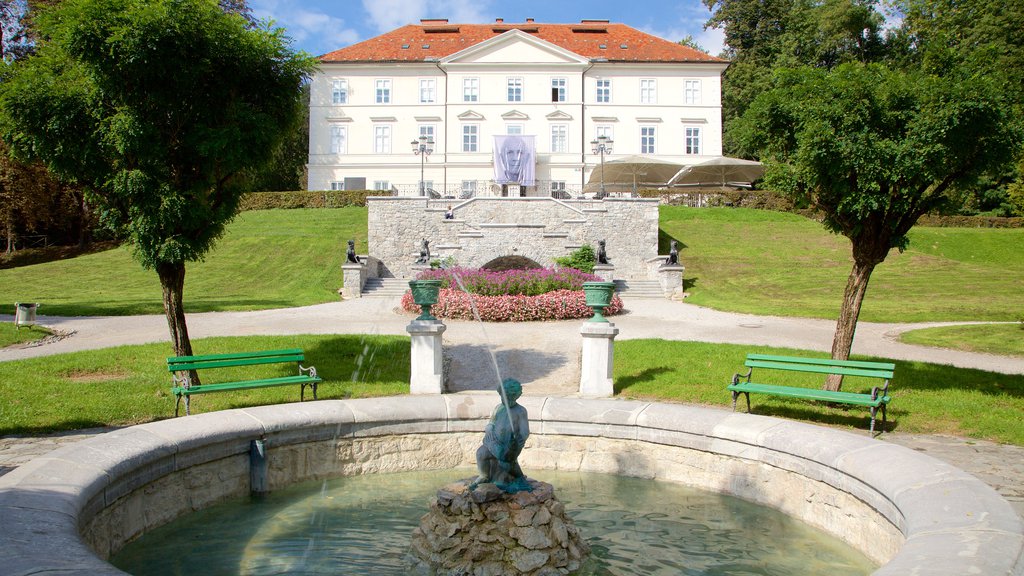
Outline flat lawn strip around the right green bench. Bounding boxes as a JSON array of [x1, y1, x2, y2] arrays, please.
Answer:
[[614, 339, 1024, 446]]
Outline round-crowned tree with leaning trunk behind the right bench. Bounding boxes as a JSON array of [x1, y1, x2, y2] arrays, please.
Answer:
[[736, 64, 1022, 389]]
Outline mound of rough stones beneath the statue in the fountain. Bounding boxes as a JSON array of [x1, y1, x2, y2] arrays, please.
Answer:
[[410, 480, 590, 576]]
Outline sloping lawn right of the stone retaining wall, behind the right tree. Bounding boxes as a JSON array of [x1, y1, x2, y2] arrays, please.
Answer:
[[659, 206, 1024, 322]]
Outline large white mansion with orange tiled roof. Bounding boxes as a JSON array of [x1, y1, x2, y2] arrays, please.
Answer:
[[308, 18, 728, 198]]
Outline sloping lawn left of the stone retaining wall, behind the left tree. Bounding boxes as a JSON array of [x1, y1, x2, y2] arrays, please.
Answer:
[[0, 207, 367, 316]]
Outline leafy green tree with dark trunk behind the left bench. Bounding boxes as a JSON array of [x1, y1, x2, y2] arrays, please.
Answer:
[[0, 0, 314, 355]]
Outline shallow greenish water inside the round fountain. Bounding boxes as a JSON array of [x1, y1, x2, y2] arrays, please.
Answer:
[[113, 469, 877, 576]]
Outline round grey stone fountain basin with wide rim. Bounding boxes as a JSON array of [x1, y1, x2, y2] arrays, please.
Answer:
[[0, 394, 1024, 576]]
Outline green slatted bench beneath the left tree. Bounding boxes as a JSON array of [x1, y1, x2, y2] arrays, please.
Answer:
[[167, 348, 322, 416]]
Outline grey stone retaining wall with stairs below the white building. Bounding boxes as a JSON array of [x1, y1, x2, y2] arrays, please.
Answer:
[[367, 197, 657, 280]]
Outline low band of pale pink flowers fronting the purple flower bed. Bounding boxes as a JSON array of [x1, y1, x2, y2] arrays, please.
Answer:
[[401, 288, 623, 322]]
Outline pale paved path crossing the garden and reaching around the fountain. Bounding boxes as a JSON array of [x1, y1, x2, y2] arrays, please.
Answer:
[[0, 298, 1024, 516]]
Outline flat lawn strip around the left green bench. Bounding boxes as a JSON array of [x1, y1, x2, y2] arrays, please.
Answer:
[[0, 335, 410, 436]]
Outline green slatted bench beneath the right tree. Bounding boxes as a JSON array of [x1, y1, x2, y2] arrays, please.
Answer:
[[727, 354, 896, 436]]
